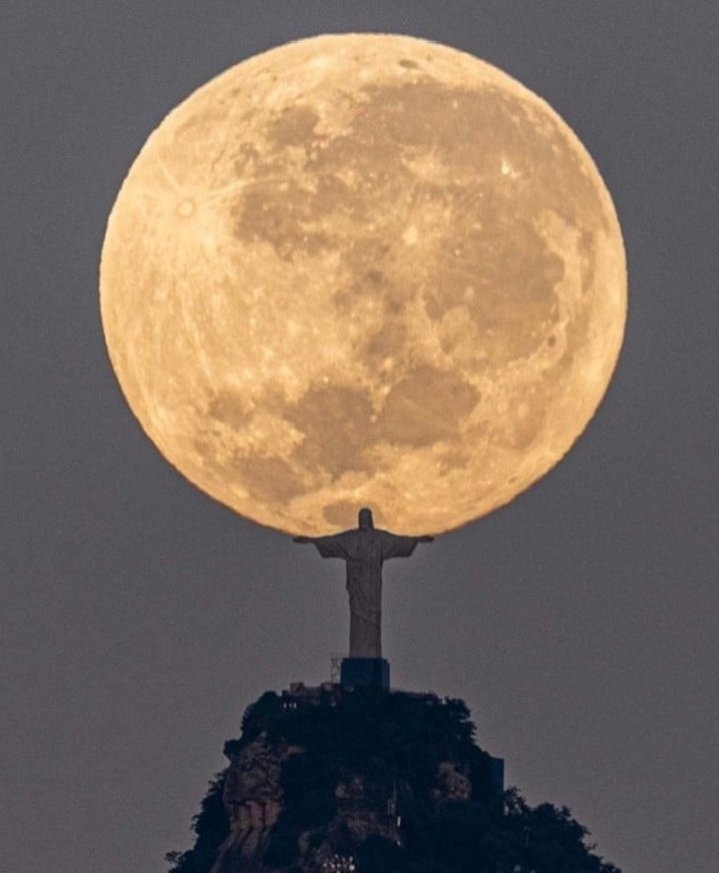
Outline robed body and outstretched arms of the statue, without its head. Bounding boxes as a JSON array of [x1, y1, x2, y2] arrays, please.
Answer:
[[310, 527, 418, 658]]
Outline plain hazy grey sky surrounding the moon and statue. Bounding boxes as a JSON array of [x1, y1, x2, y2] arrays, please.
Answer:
[[0, 0, 719, 873]]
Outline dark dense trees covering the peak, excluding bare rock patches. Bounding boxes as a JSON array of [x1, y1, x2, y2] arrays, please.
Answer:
[[167, 692, 620, 873]]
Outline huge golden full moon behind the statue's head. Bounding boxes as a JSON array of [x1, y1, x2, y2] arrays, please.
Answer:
[[100, 34, 626, 535]]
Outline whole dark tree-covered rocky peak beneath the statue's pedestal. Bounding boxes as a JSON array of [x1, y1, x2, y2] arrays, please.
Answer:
[[168, 686, 620, 873]]
